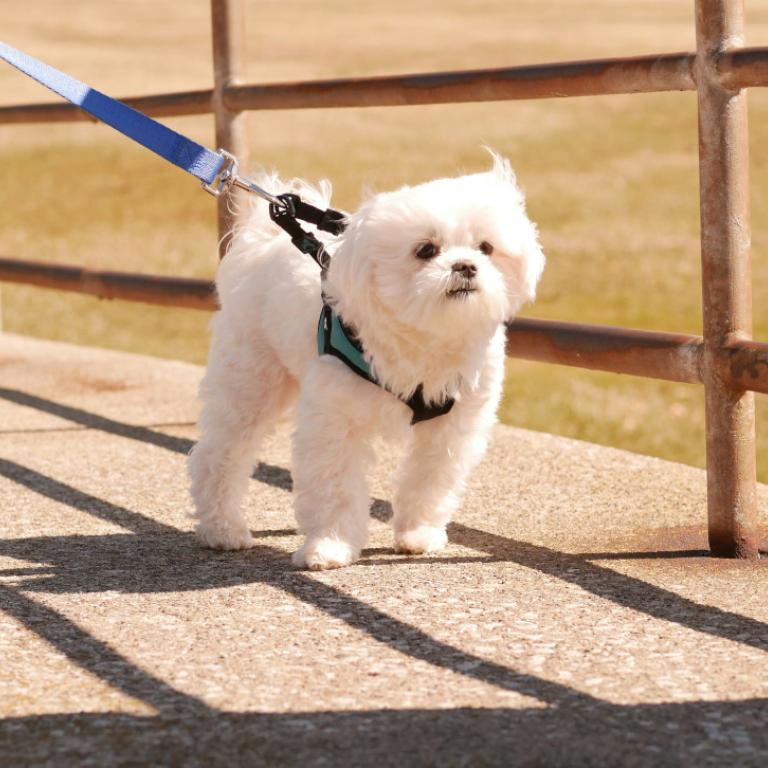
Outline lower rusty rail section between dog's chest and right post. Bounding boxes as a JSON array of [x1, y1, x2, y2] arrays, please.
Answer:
[[507, 318, 702, 383]]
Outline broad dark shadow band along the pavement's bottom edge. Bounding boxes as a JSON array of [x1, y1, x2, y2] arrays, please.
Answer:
[[0, 698, 768, 768]]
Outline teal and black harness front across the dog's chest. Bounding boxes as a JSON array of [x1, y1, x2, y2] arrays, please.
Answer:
[[317, 304, 455, 424]]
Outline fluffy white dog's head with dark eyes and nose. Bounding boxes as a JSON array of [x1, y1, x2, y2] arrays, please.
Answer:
[[328, 154, 544, 337]]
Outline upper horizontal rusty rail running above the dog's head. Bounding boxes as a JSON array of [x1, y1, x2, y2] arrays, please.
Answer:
[[0, 48, 768, 124]]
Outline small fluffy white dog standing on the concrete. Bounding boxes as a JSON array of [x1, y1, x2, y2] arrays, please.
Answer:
[[189, 155, 544, 570]]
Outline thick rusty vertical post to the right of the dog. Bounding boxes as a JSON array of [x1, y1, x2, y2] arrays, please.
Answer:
[[696, 0, 758, 558]]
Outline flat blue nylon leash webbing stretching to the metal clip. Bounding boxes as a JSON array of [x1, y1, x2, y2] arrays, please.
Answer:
[[0, 43, 224, 184]]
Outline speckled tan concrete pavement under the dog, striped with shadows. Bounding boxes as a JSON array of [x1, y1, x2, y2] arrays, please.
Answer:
[[0, 334, 768, 766]]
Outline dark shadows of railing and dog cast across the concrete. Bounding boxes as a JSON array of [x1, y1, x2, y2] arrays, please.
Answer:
[[0, 390, 768, 765]]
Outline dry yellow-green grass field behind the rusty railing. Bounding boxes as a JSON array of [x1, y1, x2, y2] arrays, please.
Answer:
[[0, 0, 768, 481]]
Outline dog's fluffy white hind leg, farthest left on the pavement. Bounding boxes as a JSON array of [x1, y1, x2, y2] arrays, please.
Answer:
[[188, 316, 297, 549]]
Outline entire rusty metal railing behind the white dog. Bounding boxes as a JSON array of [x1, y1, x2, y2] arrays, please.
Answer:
[[0, 0, 768, 559]]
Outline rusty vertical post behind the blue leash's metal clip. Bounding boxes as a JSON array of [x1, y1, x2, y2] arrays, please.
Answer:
[[211, 0, 248, 258]]
